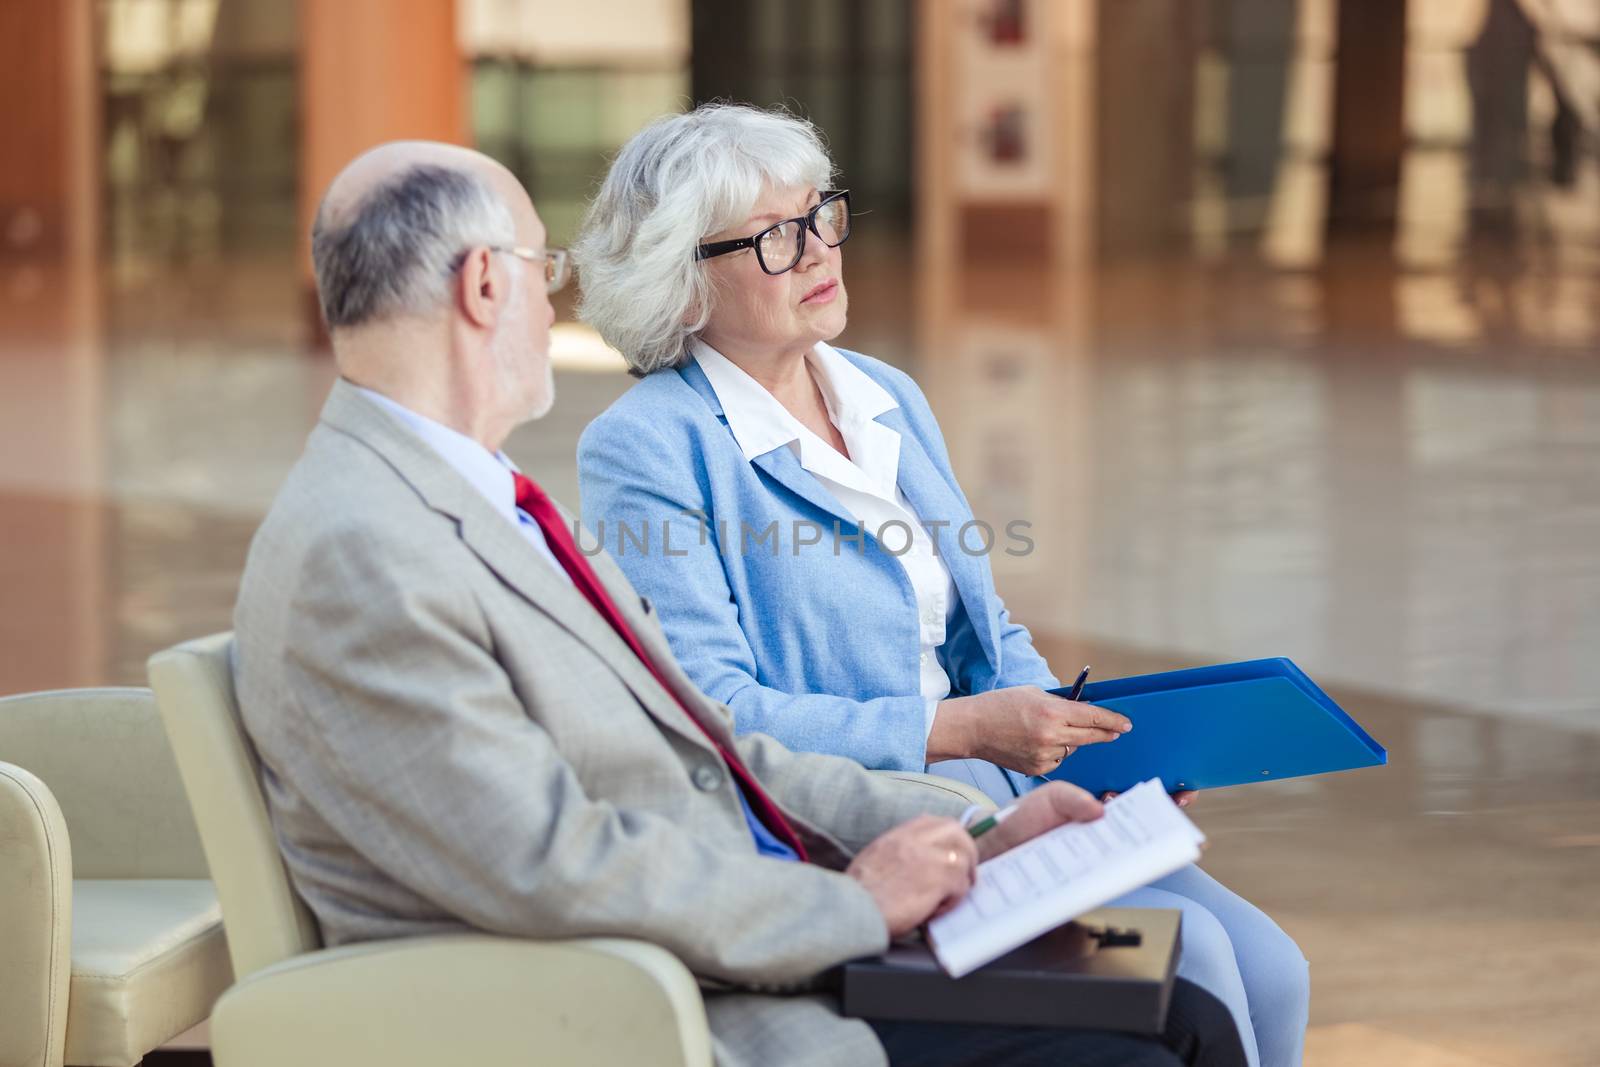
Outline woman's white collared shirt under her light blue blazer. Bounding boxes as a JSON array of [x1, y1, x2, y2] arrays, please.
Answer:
[[690, 338, 957, 748]]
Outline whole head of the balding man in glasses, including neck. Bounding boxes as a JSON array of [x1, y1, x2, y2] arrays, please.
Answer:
[[310, 141, 555, 451]]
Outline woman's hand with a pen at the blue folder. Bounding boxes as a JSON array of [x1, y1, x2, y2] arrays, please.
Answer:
[[928, 685, 1133, 774]]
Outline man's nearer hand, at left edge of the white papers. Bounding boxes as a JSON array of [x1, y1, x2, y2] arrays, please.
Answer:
[[845, 816, 979, 937]]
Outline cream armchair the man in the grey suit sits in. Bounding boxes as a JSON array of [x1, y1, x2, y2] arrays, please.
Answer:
[[150, 633, 982, 1067]]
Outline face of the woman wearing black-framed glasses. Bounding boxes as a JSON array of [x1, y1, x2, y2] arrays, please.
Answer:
[[701, 186, 850, 360]]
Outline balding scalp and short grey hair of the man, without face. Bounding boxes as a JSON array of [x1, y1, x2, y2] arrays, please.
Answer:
[[312, 141, 538, 333]]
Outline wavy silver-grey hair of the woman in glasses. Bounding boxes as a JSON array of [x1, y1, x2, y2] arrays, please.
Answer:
[[573, 104, 834, 378]]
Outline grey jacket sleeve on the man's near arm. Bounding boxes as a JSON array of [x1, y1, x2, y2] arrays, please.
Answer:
[[280, 530, 888, 985]]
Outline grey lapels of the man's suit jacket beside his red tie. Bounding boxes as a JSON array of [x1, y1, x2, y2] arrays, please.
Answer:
[[322, 379, 725, 747]]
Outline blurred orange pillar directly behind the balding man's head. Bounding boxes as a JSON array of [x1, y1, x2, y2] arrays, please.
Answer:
[[299, 0, 470, 333]]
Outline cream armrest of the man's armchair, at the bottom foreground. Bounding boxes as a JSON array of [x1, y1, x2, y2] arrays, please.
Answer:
[[211, 934, 712, 1067]]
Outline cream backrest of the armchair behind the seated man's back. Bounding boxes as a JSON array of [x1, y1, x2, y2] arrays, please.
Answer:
[[150, 633, 322, 979]]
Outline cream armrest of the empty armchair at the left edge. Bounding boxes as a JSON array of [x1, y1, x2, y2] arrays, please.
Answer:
[[0, 763, 72, 1067]]
